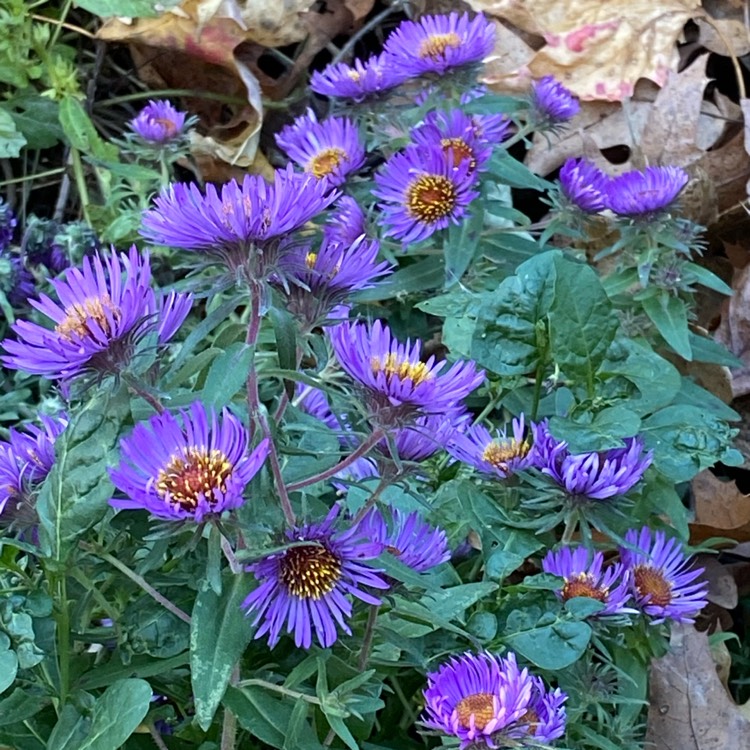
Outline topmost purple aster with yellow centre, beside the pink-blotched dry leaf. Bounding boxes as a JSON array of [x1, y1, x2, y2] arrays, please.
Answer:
[[384, 11, 495, 77]]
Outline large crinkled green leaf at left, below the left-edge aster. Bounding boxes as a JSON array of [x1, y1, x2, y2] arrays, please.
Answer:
[[36, 388, 129, 562]]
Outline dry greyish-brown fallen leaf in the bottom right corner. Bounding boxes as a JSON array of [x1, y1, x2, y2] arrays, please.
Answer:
[[646, 623, 750, 750]]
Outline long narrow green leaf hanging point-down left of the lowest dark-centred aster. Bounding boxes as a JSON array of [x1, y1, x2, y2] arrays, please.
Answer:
[[190, 574, 253, 730]]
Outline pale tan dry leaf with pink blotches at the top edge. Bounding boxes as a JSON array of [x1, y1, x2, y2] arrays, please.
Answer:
[[469, 0, 702, 101]]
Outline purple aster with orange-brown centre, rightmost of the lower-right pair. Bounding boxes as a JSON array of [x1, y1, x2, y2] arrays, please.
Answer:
[[620, 527, 708, 624]]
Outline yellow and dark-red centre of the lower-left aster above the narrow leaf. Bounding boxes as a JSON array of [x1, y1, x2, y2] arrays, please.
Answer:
[[156, 448, 234, 511]]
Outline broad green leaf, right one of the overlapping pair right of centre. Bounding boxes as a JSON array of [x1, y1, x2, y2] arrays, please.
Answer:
[[549, 255, 618, 395]]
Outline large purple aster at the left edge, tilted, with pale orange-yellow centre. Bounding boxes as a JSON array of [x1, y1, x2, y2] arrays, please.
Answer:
[[2, 246, 192, 380]]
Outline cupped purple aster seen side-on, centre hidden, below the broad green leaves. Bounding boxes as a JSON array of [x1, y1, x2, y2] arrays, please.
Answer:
[[534, 421, 653, 500]]
